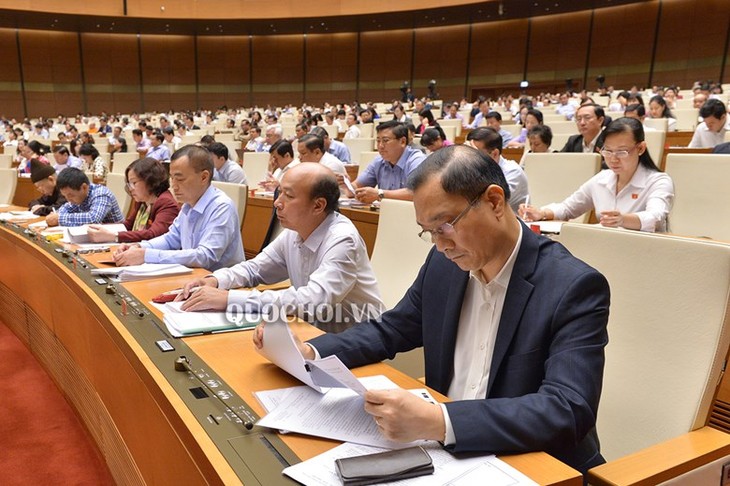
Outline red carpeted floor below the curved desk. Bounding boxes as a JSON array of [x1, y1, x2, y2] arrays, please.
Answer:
[[0, 322, 114, 486]]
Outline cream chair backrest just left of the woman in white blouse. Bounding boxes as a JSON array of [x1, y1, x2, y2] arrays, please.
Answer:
[[523, 153, 601, 222]]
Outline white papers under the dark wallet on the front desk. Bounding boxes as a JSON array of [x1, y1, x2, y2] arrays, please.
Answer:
[[282, 442, 537, 486]]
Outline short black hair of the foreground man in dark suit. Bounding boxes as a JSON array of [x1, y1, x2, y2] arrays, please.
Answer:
[[408, 145, 510, 201]]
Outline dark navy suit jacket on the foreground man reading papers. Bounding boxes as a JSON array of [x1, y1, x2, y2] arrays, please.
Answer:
[[310, 225, 609, 472]]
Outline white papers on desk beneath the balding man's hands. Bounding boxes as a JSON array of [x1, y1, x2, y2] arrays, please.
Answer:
[[159, 302, 261, 337]]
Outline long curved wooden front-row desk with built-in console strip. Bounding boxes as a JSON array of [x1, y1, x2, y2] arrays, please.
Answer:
[[0, 215, 582, 485]]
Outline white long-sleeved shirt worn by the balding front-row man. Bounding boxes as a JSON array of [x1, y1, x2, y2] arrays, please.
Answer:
[[213, 213, 384, 332]]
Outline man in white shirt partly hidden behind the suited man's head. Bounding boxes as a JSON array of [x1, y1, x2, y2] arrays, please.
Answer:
[[466, 127, 530, 213]]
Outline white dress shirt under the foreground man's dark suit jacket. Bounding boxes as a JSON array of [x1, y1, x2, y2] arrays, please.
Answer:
[[441, 224, 522, 445]]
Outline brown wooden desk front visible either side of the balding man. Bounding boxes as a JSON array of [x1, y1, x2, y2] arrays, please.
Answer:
[[241, 196, 380, 258]]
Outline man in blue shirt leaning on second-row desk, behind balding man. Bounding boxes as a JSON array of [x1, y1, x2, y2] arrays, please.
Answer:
[[352, 120, 426, 203]]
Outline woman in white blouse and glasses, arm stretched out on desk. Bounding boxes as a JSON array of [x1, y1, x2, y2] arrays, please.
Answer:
[[520, 118, 674, 232]]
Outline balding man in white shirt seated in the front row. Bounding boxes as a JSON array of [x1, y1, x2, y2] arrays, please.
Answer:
[[180, 164, 383, 332]]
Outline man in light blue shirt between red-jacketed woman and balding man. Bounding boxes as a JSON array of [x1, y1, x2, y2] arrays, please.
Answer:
[[114, 145, 245, 270]]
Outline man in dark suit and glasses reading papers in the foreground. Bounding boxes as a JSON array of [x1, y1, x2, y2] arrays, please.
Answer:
[[254, 146, 609, 472]]
